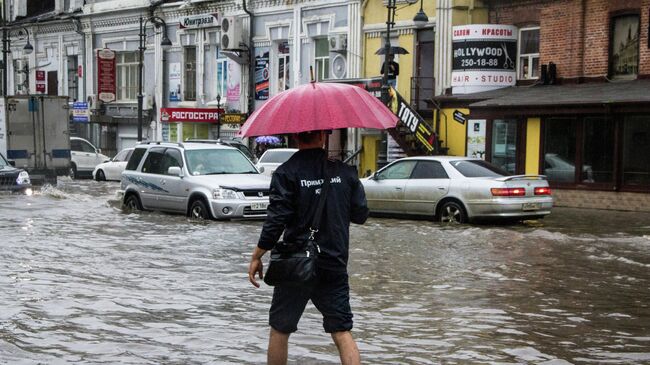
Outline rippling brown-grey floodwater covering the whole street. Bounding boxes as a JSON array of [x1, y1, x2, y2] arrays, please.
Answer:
[[0, 180, 650, 365]]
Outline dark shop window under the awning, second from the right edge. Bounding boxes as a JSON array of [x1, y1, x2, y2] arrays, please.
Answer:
[[579, 117, 615, 183]]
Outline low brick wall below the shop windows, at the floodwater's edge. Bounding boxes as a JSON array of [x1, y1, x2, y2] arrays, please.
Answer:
[[553, 189, 650, 212]]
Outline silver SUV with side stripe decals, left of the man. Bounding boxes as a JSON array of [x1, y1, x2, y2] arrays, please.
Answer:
[[120, 142, 271, 219]]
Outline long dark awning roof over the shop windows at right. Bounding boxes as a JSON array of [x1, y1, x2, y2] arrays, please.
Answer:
[[434, 79, 650, 118]]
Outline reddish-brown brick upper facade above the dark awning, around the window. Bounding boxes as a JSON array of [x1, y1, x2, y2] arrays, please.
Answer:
[[489, 0, 650, 79]]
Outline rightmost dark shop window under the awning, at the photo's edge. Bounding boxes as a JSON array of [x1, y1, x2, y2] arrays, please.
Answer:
[[623, 115, 650, 188]]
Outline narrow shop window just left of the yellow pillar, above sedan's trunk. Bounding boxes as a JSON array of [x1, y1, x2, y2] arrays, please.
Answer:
[[491, 119, 518, 174]]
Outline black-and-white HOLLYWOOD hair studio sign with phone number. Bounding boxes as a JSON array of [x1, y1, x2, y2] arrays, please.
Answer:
[[451, 24, 517, 94]]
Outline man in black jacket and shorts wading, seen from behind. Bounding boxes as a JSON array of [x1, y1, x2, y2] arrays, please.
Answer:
[[248, 131, 368, 365]]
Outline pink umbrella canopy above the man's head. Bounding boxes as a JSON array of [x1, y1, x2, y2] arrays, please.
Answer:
[[239, 82, 398, 137]]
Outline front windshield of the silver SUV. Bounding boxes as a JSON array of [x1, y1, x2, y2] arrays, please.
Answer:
[[185, 148, 258, 175]]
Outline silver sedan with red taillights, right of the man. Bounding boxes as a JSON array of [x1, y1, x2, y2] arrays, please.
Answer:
[[362, 156, 553, 223]]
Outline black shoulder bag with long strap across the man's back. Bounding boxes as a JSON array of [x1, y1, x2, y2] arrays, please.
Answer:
[[264, 160, 330, 286]]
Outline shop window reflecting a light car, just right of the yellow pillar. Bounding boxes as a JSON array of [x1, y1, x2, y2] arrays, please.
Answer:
[[542, 118, 577, 183]]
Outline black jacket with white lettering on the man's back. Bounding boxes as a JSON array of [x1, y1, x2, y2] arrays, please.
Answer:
[[257, 148, 368, 270]]
